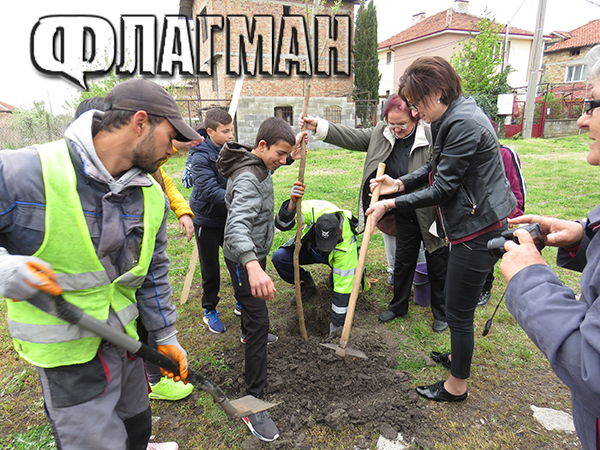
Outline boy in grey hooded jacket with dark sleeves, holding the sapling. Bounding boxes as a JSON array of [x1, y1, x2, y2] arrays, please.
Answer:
[[217, 117, 306, 442]]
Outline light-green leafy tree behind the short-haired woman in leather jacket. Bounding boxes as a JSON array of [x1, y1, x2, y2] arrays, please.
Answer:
[[450, 18, 512, 122]]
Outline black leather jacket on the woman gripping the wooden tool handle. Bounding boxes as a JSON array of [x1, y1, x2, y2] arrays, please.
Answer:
[[396, 96, 517, 240]]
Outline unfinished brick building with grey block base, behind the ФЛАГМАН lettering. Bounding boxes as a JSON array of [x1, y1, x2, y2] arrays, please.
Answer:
[[180, 0, 355, 143]]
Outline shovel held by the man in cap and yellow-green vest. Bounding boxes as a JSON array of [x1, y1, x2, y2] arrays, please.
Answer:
[[27, 292, 277, 418]]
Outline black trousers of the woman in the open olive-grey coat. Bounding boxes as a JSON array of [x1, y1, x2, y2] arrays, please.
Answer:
[[388, 211, 448, 322]]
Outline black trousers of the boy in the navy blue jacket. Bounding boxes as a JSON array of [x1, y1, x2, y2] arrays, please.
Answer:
[[194, 224, 225, 311]]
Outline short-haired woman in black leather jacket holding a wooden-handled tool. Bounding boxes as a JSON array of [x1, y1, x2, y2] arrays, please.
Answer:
[[367, 56, 517, 402]]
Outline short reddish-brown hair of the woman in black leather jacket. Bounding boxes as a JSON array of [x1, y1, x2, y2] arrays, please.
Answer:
[[398, 56, 462, 105]]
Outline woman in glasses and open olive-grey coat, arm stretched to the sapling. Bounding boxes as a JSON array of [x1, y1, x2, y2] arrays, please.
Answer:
[[299, 94, 448, 332]]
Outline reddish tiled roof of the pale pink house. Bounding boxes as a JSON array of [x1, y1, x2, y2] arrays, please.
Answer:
[[377, 8, 533, 50]]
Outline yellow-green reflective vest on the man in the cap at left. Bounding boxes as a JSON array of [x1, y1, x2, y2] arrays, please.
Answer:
[[7, 141, 164, 368]]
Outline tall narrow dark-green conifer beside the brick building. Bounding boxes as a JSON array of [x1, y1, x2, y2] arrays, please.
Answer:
[[354, 0, 381, 126]]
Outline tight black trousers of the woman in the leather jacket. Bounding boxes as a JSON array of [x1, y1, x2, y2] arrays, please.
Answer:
[[446, 223, 508, 380]]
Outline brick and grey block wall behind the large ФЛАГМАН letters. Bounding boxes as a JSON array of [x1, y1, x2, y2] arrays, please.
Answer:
[[186, 0, 354, 148]]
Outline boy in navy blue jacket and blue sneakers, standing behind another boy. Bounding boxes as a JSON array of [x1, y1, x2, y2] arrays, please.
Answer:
[[190, 108, 233, 333]]
